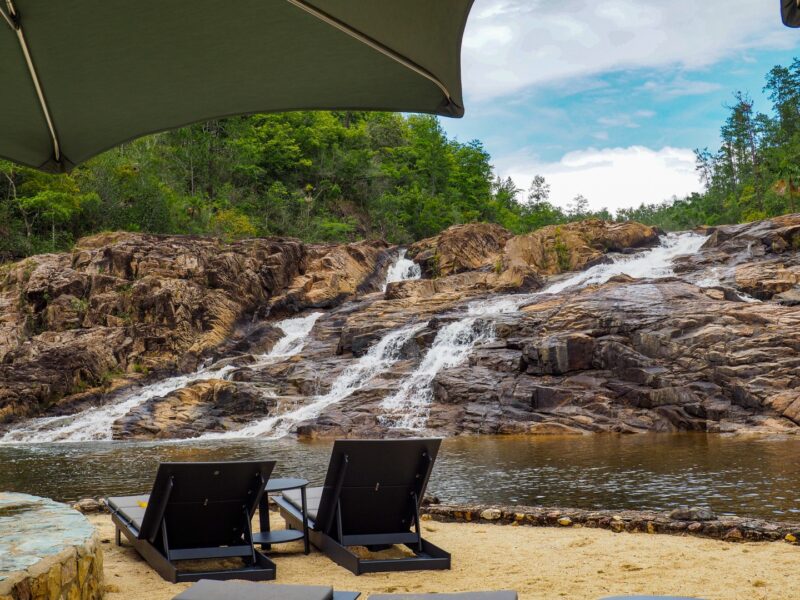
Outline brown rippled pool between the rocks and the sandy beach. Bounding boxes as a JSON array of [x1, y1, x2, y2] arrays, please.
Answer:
[[0, 434, 800, 519]]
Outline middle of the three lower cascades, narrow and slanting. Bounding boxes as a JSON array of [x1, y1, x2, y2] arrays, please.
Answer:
[[200, 323, 425, 439]]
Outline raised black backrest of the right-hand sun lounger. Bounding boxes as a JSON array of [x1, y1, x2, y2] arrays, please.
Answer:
[[316, 439, 441, 537]]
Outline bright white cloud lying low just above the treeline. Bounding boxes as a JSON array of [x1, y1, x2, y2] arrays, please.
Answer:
[[504, 146, 702, 211]]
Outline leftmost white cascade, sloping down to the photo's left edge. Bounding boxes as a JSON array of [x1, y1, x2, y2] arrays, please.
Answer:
[[0, 313, 322, 443]]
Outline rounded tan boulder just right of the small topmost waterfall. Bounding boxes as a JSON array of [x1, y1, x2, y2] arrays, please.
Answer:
[[408, 223, 512, 277]]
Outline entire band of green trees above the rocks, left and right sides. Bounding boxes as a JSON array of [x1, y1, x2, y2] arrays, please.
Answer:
[[0, 59, 800, 261]]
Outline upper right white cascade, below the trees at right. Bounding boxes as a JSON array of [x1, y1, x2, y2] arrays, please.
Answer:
[[544, 233, 706, 294]]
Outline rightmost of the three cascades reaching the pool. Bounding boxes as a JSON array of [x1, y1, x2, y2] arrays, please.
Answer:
[[379, 296, 530, 429]]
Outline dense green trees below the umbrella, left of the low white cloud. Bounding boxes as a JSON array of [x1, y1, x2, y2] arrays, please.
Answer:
[[0, 112, 604, 259]]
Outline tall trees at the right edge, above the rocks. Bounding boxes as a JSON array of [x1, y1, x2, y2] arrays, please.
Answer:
[[617, 59, 800, 230]]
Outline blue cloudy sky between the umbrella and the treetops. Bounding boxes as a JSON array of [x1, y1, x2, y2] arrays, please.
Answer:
[[442, 0, 800, 211]]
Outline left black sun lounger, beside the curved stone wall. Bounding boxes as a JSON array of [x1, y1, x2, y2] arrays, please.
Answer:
[[108, 461, 275, 583]]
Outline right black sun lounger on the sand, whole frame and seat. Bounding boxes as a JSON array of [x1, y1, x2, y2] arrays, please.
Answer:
[[275, 439, 450, 575]]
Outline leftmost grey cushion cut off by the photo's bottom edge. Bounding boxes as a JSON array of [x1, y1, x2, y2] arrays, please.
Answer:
[[173, 579, 333, 600]]
